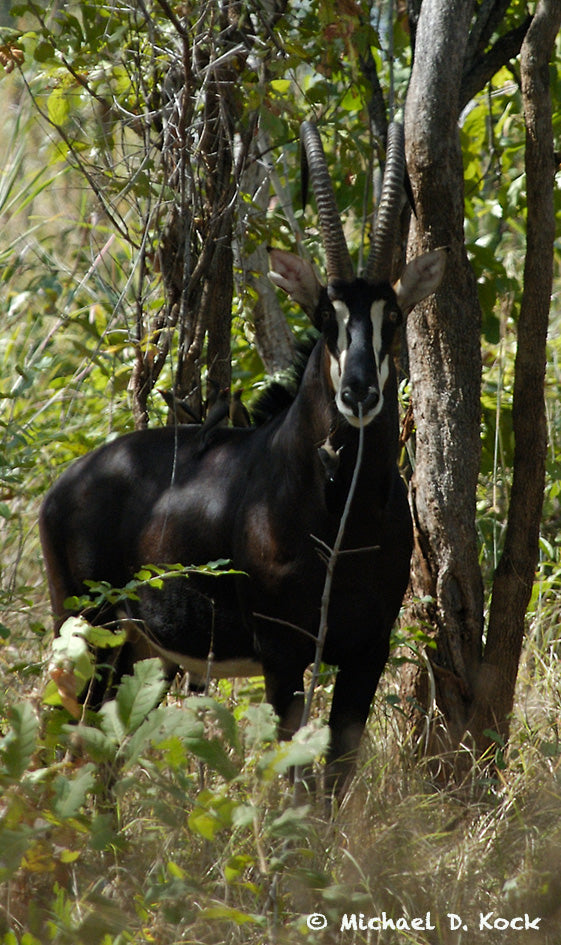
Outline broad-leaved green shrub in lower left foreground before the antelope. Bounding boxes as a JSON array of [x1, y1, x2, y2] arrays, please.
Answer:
[[0, 660, 332, 943]]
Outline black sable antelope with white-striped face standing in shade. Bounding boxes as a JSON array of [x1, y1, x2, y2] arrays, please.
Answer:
[[40, 122, 446, 794]]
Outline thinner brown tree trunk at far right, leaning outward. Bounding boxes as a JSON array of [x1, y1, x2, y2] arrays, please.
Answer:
[[470, 0, 561, 749]]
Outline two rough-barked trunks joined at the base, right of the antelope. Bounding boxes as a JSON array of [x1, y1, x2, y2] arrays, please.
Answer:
[[400, 0, 561, 753]]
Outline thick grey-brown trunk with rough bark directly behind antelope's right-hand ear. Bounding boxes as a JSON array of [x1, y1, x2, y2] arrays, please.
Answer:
[[405, 0, 483, 747]]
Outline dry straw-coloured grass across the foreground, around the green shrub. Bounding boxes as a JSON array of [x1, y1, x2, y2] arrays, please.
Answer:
[[0, 600, 561, 945]]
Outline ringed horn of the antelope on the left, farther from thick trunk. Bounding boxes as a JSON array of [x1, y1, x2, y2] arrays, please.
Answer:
[[300, 121, 355, 282]]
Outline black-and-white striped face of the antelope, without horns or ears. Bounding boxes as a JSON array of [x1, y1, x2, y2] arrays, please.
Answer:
[[323, 279, 402, 427]]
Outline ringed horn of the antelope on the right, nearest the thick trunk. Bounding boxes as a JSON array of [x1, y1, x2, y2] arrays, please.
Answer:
[[365, 122, 405, 282]]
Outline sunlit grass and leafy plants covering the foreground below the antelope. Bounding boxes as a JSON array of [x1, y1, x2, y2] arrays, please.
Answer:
[[0, 604, 561, 945]]
